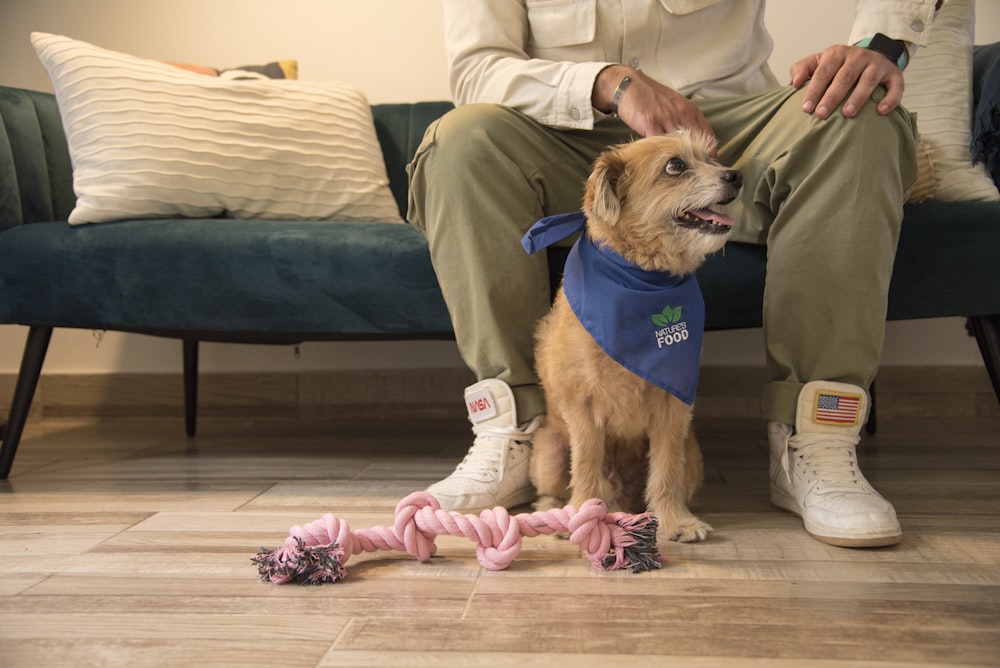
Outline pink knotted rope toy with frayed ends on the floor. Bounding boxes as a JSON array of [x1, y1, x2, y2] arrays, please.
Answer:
[[251, 492, 662, 584]]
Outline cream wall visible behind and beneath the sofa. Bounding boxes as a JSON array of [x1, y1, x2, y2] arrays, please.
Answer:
[[0, 0, 1000, 373]]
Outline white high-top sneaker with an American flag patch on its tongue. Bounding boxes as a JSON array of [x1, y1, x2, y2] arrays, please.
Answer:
[[767, 381, 902, 547]]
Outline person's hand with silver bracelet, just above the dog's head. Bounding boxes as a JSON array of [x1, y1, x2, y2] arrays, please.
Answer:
[[593, 65, 715, 146]]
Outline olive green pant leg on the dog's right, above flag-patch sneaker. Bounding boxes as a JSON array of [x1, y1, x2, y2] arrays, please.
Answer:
[[704, 89, 917, 424]]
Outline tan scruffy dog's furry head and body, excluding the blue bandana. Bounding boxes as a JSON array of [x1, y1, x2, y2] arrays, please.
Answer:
[[531, 132, 742, 542]]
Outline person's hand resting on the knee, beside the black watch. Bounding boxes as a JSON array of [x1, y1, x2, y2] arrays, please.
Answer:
[[789, 45, 903, 118]]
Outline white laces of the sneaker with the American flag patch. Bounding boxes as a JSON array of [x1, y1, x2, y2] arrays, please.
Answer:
[[783, 434, 870, 492]]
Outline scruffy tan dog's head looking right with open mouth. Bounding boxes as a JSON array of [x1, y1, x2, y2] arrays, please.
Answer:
[[583, 132, 743, 274]]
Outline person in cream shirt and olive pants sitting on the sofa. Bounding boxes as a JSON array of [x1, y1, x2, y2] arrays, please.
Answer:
[[408, 0, 936, 547]]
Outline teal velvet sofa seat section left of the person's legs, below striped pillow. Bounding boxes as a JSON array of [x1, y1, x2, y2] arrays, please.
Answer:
[[0, 219, 451, 342]]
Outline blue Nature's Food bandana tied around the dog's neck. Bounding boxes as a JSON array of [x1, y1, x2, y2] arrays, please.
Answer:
[[521, 212, 705, 404]]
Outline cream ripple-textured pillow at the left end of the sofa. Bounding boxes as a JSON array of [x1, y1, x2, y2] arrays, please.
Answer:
[[31, 33, 403, 224]]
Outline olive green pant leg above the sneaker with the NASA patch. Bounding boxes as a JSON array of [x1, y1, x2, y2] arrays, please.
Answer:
[[408, 104, 628, 422]]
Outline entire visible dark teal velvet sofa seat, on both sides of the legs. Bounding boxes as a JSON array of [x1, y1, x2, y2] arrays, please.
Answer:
[[9, 197, 1000, 343]]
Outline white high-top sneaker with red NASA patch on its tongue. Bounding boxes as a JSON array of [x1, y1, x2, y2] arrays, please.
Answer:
[[427, 378, 541, 513]]
